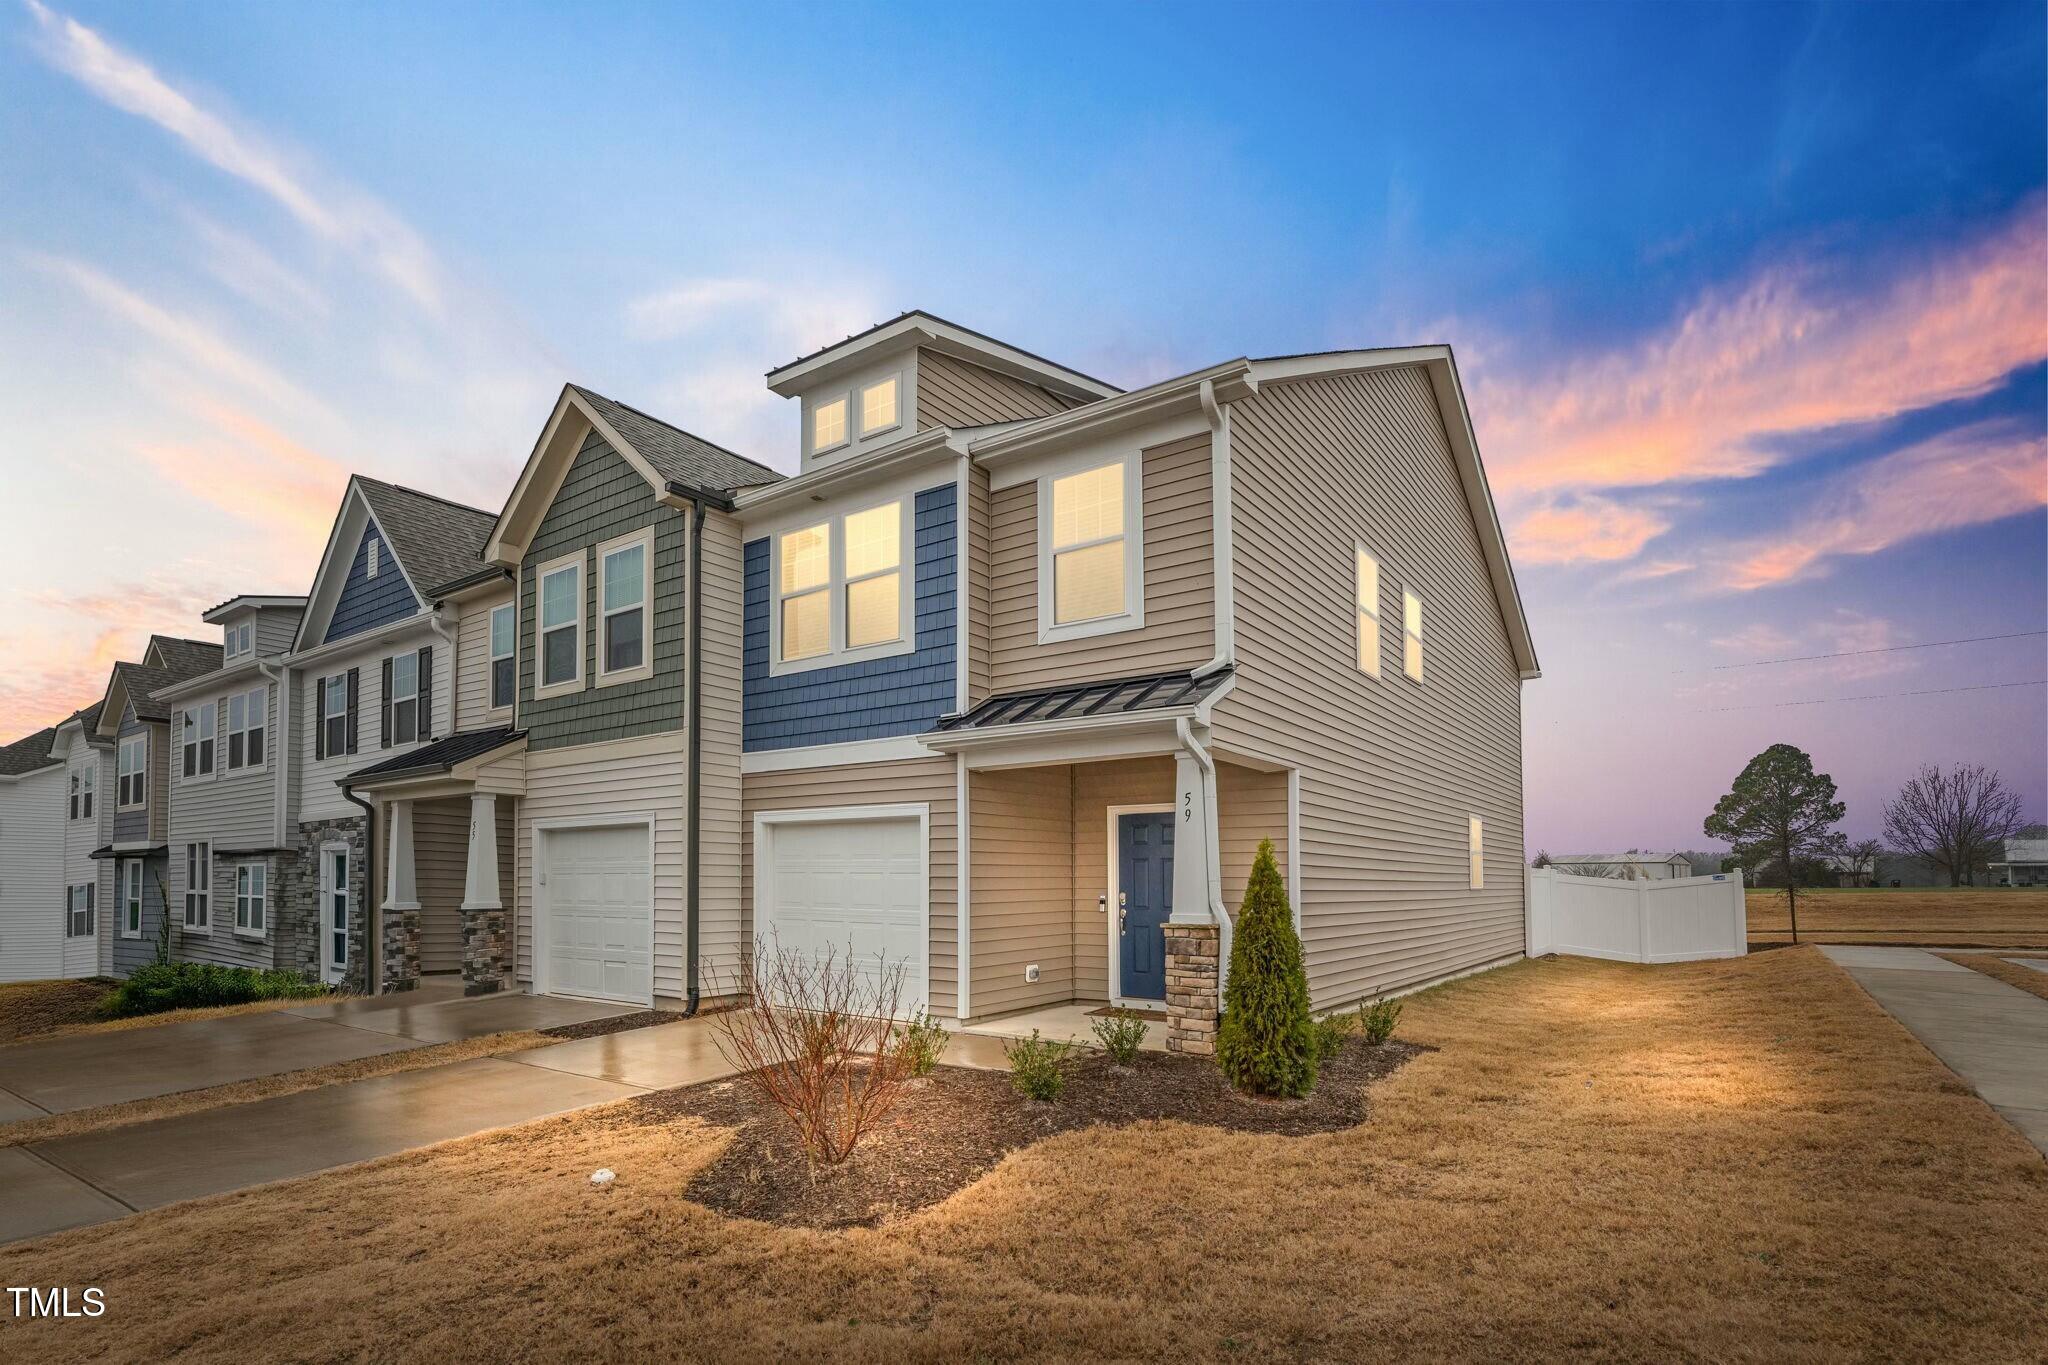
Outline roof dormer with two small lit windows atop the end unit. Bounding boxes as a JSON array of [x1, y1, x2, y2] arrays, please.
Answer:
[[768, 313, 1120, 473]]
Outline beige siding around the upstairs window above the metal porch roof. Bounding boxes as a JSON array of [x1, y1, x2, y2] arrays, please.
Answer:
[[989, 434, 1217, 692]]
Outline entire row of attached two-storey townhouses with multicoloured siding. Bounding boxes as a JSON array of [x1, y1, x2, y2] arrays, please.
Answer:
[[0, 313, 1538, 1050]]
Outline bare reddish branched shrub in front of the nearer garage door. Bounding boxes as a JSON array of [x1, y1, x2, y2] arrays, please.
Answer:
[[711, 939, 909, 1164]]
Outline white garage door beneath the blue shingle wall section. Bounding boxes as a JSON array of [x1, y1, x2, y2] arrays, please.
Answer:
[[756, 817, 930, 1015]]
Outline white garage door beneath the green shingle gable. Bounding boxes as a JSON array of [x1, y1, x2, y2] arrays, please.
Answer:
[[541, 825, 653, 1005]]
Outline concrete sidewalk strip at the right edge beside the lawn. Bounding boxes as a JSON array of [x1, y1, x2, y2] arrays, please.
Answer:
[[1821, 945, 2048, 1154]]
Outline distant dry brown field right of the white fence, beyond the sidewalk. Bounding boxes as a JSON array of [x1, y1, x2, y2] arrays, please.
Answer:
[[1749, 886, 2048, 948]]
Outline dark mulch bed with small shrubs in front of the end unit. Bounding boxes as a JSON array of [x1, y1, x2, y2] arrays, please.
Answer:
[[637, 1038, 1423, 1228]]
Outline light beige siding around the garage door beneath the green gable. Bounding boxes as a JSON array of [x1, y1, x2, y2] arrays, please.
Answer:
[[514, 731, 692, 1001]]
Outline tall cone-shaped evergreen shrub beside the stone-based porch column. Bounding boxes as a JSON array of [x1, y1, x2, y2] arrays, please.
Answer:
[[1217, 839, 1315, 1099]]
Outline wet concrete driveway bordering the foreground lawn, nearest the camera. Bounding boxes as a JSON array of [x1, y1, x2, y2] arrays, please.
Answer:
[[0, 1010, 731, 1242]]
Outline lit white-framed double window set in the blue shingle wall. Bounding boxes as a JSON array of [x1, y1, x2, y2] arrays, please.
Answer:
[[770, 495, 915, 673]]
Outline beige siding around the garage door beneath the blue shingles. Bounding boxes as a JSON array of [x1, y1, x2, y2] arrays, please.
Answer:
[[741, 757, 954, 1017]]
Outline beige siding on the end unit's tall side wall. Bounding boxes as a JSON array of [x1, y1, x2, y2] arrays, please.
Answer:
[[1214, 368, 1524, 1007]]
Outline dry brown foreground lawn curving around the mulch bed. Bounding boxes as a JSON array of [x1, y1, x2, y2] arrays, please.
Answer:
[[0, 948, 2048, 1365]]
